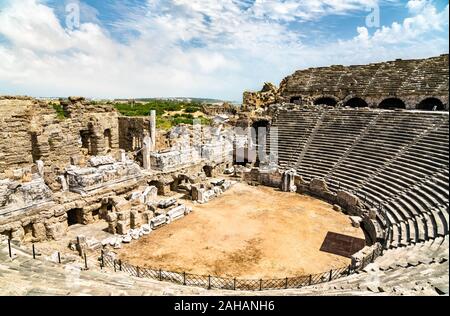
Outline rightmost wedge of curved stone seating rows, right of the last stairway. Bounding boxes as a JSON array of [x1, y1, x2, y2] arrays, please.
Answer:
[[360, 121, 448, 246]]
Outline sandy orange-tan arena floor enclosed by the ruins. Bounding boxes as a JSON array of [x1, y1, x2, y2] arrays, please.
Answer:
[[119, 183, 364, 278]]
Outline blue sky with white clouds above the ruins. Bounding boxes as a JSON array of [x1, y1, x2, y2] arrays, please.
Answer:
[[0, 0, 449, 101]]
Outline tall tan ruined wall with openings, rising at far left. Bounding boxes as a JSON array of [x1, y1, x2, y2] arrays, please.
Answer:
[[0, 97, 119, 178]]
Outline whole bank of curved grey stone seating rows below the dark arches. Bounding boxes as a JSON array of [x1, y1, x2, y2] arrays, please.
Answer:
[[268, 109, 449, 247]]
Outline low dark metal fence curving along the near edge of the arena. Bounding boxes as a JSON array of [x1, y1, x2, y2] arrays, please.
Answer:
[[100, 250, 380, 291]]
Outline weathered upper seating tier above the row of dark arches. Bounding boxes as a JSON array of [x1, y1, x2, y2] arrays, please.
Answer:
[[279, 54, 449, 110]]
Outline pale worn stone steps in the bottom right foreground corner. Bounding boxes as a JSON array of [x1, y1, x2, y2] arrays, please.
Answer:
[[264, 236, 449, 296]]
